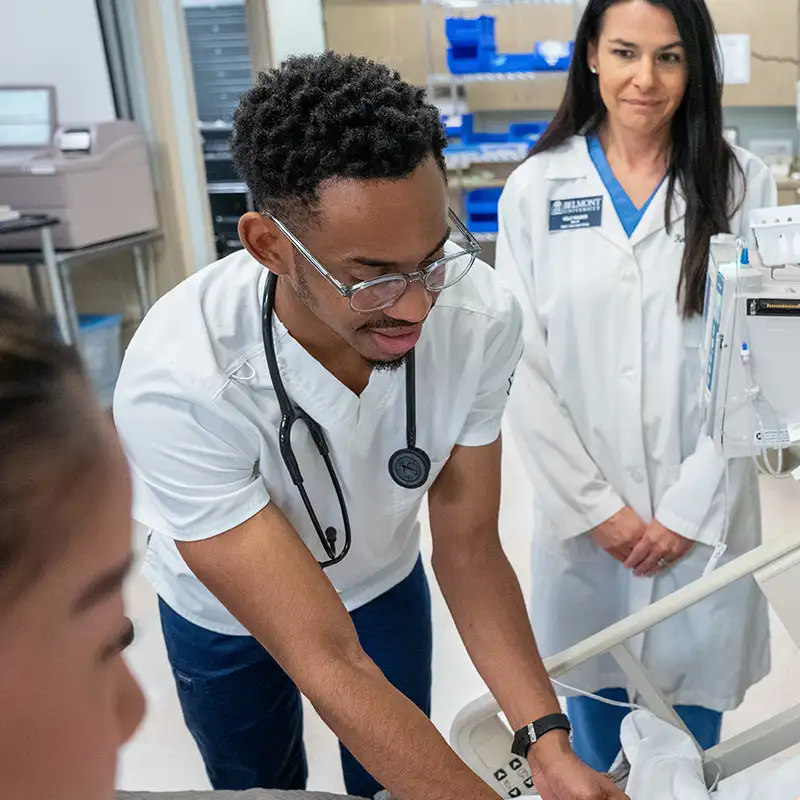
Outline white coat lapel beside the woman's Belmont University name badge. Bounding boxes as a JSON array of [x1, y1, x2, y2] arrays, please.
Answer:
[[546, 136, 633, 256]]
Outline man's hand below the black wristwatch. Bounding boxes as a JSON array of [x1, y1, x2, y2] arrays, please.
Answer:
[[528, 731, 628, 800]]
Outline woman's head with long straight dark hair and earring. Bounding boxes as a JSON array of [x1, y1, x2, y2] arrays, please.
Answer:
[[533, 0, 741, 315]]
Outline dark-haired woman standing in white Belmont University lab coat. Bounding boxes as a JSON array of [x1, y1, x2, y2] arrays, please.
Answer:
[[497, 0, 777, 770]]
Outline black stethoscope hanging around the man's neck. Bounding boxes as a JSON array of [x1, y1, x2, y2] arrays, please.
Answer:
[[261, 272, 431, 569]]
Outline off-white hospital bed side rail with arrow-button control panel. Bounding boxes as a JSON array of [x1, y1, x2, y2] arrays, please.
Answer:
[[451, 534, 800, 800]]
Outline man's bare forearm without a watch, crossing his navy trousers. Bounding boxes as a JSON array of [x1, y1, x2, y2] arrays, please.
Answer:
[[300, 657, 497, 800]]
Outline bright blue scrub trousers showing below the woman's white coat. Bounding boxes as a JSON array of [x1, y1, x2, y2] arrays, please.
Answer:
[[567, 689, 722, 772]]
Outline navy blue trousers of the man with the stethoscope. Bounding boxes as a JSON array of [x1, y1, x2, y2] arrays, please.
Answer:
[[160, 561, 433, 797]]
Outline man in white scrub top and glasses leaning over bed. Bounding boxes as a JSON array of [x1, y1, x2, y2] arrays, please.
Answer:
[[115, 54, 623, 800]]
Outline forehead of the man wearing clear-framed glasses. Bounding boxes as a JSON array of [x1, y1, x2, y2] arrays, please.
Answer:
[[303, 159, 448, 264]]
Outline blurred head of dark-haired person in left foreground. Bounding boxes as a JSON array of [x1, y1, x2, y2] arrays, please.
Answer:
[[0, 294, 144, 800]]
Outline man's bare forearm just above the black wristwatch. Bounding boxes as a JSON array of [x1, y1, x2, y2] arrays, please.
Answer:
[[433, 537, 560, 730]]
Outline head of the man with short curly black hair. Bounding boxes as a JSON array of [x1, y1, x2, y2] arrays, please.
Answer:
[[232, 53, 466, 366]]
